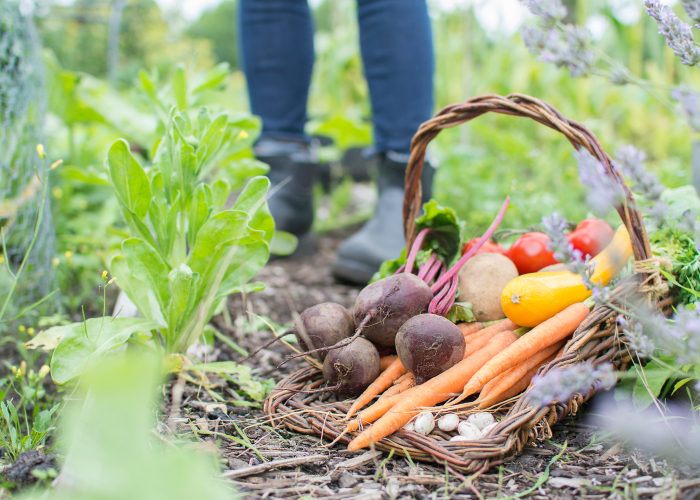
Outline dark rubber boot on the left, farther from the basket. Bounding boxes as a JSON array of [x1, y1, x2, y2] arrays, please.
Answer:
[[255, 139, 318, 257]]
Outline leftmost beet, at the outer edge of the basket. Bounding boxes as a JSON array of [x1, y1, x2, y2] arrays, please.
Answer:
[[293, 302, 355, 361]]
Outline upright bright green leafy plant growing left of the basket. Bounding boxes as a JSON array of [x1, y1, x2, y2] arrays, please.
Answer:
[[34, 101, 274, 383]]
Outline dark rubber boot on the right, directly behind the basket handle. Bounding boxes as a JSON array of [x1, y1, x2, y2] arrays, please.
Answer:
[[331, 152, 434, 285]]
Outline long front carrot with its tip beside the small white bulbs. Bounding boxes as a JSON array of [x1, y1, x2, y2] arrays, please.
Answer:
[[348, 331, 518, 451]]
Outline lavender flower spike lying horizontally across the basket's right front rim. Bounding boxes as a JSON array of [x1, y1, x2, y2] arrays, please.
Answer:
[[528, 363, 617, 406]]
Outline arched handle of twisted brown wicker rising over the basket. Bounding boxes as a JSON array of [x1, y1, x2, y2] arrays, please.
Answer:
[[403, 94, 651, 260]]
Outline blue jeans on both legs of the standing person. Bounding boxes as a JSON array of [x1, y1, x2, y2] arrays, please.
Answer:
[[239, 0, 434, 153]]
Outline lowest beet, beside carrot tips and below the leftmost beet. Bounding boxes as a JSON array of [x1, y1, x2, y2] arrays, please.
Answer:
[[323, 337, 380, 397]]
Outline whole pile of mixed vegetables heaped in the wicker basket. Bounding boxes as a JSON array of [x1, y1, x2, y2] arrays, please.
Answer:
[[264, 199, 632, 450]]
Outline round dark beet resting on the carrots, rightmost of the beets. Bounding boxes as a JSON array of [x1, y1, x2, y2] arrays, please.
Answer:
[[396, 314, 466, 384]]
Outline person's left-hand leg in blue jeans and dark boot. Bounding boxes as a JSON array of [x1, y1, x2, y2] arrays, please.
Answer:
[[239, 0, 317, 245]]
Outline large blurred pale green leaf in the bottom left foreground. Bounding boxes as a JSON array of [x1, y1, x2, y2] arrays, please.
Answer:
[[20, 354, 231, 500]]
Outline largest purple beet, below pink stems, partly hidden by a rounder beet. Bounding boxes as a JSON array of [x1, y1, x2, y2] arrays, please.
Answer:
[[355, 273, 433, 346]]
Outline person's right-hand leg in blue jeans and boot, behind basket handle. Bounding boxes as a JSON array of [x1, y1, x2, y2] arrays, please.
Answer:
[[333, 0, 434, 283]]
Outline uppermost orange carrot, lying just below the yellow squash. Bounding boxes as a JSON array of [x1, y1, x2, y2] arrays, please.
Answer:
[[458, 302, 590, 400]]
